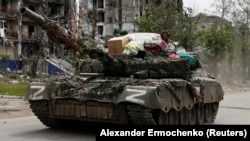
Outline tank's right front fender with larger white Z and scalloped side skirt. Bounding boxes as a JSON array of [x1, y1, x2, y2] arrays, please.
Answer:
[[117, 83, 194, 112]]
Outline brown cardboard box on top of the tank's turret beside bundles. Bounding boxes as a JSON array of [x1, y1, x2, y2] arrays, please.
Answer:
[[108, 35, 130, 55]]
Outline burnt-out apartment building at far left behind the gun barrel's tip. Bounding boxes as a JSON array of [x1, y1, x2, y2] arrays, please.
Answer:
[[0, 0, 69, 72]]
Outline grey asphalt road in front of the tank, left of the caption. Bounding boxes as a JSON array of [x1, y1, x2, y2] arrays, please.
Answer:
[[0, 116, 95, 141]]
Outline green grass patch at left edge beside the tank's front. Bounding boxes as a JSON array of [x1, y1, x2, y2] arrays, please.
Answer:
[[0, 74, 29, 96]]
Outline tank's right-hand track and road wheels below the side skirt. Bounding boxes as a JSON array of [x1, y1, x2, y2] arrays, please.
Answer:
[[127, 102, 219, 125]]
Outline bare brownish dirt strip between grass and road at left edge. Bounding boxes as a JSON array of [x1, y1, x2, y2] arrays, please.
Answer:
[[0, 95, 34, 119]]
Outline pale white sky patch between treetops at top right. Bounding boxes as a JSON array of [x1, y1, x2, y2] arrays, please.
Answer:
[[182, 0, 214, 15]]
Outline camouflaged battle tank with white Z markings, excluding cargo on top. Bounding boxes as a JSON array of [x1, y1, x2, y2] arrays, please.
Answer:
[[20, 7, 224, 128]]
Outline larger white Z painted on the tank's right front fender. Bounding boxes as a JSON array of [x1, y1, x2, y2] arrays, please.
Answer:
[[126, 89, 146, 104]]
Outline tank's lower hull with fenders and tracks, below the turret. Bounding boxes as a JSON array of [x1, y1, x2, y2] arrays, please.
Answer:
[[27, 77, 224, 127]]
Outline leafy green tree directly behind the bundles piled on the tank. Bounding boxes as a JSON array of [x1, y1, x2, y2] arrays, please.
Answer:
[[135, 0, 197, 50]]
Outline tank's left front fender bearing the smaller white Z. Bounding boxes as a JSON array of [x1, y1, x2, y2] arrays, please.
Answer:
[[25, 82, 49, 100]]
